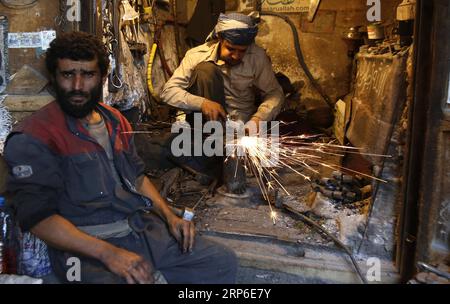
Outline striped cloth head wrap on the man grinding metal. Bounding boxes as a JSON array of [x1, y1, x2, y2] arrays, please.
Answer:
[[206, 13, 258, 45]]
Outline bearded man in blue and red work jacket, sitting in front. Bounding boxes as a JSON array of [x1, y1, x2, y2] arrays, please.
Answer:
[[4, 32, 236, 283]]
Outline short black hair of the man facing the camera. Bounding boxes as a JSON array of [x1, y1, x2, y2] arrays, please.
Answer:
[[45, 32, 109, 77]]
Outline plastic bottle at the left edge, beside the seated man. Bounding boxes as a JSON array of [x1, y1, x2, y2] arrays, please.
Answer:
[[0, 196, 17, 274]]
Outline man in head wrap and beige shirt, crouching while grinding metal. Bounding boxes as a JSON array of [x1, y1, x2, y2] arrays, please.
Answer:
[[161, 13, 284, 191]]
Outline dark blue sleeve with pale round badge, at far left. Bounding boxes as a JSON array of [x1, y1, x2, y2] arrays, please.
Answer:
[[4, 133, 63, 231]]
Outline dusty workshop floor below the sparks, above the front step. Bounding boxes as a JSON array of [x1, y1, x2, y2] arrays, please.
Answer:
[[156, 166, 369, 252]]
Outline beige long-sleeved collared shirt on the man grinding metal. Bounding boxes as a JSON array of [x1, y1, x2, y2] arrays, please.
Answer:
[[161, 42, 284, 122]]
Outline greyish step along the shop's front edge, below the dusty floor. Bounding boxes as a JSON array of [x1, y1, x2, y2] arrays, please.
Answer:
[[202, 231, 400, 284]]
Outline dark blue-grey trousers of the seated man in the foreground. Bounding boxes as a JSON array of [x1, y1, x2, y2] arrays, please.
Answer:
[[50, 212, 237, 284]]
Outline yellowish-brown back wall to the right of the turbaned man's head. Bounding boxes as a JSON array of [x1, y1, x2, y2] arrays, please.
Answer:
[[227, 0, 401, 110]]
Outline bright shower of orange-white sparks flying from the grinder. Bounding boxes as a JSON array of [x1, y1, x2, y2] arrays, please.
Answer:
[[225, 135, 390, 224]]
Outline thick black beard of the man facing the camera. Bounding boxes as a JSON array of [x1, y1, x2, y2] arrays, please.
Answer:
[[54, 82, 103, 118]]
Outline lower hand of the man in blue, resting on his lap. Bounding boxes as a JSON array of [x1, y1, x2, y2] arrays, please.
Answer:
[[101, 245, 154, 284]]
